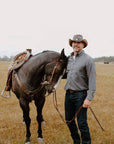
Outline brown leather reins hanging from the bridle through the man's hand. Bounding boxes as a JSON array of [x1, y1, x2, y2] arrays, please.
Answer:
[[53, 89, 104, 131]]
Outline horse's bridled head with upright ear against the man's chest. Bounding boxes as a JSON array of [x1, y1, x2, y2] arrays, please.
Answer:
[[45, 49, 67, 93]]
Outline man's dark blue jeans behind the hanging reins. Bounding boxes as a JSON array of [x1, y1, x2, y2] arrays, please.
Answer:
[[65, 91, 91, 144]]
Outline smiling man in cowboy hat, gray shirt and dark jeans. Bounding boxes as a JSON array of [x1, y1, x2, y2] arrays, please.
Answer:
[[65, 34, 96, 144]]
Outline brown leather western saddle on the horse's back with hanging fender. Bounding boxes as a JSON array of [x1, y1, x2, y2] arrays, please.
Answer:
[[5, 49, 32, 91]]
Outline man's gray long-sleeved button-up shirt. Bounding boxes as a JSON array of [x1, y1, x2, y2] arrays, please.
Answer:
[[65, 50, 96, 100]]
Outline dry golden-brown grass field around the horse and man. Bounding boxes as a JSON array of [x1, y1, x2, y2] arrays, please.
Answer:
[[0, 62, 114, 144]]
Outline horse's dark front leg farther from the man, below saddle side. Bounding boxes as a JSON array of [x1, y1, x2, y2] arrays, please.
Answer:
[[19, 98, 31, 144]]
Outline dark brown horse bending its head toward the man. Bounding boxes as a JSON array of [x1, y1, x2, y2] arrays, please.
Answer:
[[12, 49, 67, 144]]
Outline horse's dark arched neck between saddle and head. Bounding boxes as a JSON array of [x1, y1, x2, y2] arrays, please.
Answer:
[[19, 51, 58, 87]]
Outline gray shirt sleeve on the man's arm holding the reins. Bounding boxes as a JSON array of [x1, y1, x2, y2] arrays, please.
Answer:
[[86, 58, 96, 100]]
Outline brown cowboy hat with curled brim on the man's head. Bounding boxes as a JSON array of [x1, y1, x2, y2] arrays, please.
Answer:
[[69, 34, 88, 48]]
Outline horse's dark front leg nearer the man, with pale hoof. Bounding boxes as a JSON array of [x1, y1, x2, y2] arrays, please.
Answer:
[[35, 97, 45, 143]]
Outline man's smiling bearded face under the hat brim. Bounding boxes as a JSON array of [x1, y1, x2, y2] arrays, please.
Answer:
[[72, 42, 84, 52]]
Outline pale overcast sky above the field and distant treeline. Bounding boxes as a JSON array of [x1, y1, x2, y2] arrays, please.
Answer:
[[0, 0, 114, 58]]
